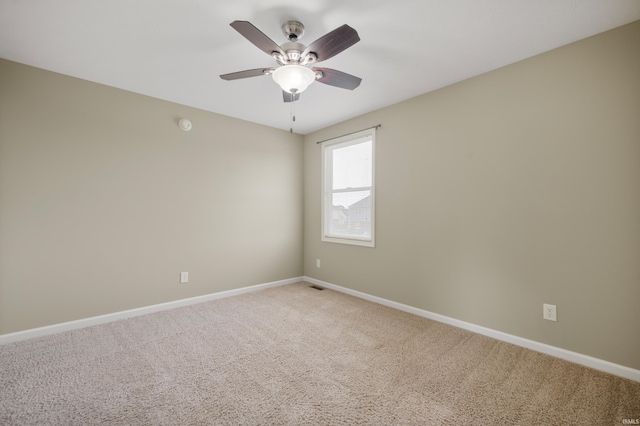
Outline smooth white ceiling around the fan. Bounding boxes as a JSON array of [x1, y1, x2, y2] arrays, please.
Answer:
[[0, 0, 640, 134]]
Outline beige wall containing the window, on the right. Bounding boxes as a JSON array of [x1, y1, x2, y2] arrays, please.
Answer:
[[304, 22, 640, 369]]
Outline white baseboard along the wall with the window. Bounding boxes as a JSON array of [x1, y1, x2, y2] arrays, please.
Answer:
[[303, 277, 640, 382]]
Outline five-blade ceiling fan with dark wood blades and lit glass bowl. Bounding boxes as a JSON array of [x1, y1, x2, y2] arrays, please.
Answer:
[[220, 21, 362, 102]]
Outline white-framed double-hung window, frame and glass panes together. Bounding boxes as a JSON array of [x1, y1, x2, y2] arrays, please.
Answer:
[[322, 128, 375, 247]]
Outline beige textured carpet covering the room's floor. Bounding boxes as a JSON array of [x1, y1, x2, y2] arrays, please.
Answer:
[[0, 283, 640, 425]]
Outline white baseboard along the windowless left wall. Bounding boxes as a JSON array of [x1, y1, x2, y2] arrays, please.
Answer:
[[0, 277, 303, 345]]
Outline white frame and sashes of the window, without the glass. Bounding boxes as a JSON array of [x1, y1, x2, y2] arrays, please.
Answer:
[[320, 127, 376, 247]]
